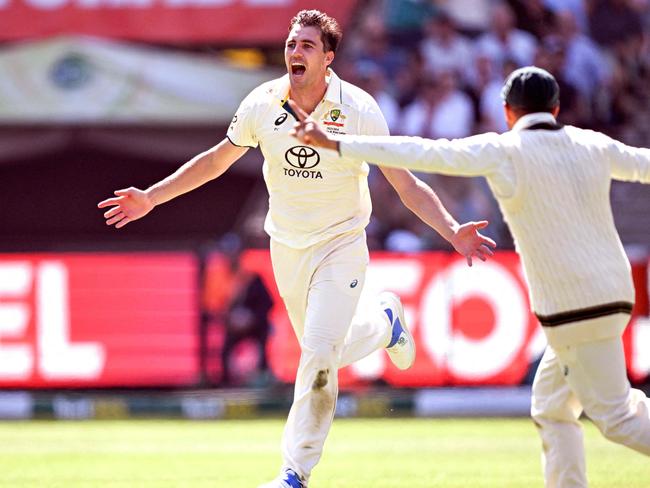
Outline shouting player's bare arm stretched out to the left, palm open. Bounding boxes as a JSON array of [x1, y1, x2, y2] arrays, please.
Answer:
[[97, 138, 248, 229]]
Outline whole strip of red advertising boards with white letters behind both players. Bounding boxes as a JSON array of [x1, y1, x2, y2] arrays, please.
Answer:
[[0, 250, 650, 389]]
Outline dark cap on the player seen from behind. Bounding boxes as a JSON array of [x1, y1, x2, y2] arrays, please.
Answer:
[[501, 66, 560, 112]]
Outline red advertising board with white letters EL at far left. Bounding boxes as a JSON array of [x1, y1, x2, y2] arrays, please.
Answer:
[[0, 253, 199, 388]]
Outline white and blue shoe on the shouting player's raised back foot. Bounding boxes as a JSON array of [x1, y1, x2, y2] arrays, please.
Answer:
[[379, 291, 415, 370]]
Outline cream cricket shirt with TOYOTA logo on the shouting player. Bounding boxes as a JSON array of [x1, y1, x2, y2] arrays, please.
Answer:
[[227, 70, 388, 249]]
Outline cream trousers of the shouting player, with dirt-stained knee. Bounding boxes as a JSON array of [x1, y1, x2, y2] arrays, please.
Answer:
[[271, 231, 391, 480]]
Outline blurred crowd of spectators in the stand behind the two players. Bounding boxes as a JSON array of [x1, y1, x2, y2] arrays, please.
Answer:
[[335, 0, 650, 251]]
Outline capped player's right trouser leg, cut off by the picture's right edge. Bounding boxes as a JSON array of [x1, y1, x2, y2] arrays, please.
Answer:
[[557, 337, 650, 455]]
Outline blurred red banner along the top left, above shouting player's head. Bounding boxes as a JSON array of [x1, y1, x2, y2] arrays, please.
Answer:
[[0, 0, 356, 45]]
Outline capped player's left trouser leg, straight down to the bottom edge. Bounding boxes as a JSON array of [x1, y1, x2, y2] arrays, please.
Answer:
[[531, 347, 587, 488]]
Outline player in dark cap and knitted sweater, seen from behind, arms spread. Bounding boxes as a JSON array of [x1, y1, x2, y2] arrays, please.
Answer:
[[293, 67, 650, 488]]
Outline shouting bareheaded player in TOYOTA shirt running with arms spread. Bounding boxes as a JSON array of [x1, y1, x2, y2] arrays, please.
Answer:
[[99, 10, 494, 488]]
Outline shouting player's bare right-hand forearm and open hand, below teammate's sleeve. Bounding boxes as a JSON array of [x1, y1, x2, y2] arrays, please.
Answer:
[[380, 166, 496, 266]]
